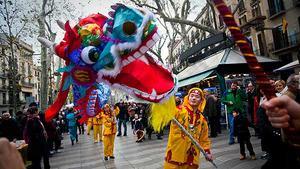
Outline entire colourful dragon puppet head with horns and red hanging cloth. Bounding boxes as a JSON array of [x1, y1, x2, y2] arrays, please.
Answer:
[[39, 4, 177, 120]]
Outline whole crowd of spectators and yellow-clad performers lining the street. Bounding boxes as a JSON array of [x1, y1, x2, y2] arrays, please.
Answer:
[[0, 75, 300, 169]]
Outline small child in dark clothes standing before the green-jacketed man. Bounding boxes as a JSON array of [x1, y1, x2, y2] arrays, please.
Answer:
[[233, 110, 256, 160]]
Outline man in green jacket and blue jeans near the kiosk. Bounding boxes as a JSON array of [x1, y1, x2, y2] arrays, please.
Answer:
[[222, 82, 246, 145]]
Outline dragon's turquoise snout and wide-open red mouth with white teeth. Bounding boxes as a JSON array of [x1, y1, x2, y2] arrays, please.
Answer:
[[94, 4, 176, 102]]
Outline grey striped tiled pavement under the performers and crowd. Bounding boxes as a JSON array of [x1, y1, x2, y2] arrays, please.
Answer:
[[50, 126, 264, 169]]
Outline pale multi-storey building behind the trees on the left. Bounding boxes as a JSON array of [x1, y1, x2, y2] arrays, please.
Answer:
[[0, 35, 40, 114]]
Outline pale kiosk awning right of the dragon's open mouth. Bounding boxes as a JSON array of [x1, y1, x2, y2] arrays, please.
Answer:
[[177, 49, 279, 87]]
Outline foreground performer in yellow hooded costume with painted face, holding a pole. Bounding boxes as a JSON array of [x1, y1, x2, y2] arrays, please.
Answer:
[[164, 88, 212, 169]]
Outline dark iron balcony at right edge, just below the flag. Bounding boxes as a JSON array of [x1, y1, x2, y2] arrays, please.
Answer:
[[268, 32, 300, 53]]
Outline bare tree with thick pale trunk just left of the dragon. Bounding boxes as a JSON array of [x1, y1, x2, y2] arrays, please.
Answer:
[[29, 0, 77, 112]]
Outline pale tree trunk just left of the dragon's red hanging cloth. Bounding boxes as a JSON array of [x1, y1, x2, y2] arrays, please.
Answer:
[[38, 14, 49, 113]]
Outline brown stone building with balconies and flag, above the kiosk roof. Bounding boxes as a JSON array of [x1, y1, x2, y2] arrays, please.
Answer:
[[168, 0, 300, 74]]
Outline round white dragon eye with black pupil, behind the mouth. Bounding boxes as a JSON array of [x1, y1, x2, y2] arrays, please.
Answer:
[[81, 46, 100, 64]]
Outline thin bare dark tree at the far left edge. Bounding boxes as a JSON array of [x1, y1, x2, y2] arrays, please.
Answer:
[[0, 0, 29, 114]]
